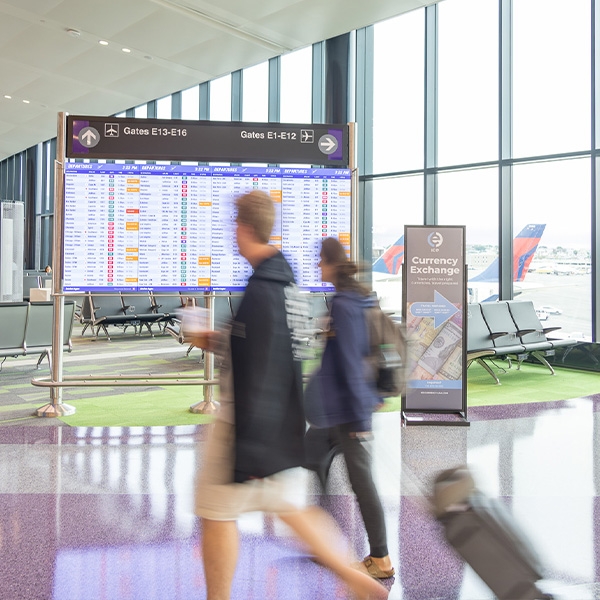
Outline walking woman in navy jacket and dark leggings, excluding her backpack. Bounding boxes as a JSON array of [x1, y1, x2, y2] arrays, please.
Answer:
[[307, 238, 394, 579]]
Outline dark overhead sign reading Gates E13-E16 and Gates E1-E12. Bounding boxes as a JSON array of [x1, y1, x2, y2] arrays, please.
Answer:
[[66, 116, 349, 167]]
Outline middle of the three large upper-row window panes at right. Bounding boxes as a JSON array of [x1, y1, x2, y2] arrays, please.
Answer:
[[438, 0, 498, 165]]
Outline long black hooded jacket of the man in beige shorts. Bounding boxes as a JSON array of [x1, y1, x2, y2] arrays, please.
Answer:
[[231, 252, 305, 483]]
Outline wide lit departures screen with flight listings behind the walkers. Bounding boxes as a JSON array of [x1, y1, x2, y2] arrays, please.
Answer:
[[63, 163, 351, 292]]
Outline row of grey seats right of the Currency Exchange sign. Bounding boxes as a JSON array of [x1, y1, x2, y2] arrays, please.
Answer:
[[467, 300, 577, 384]]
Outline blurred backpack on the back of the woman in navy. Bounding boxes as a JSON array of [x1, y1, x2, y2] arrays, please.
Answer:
[[365, 301, 406, 398]]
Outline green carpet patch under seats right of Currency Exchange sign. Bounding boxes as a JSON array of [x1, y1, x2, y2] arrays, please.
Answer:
[[467, 363, 600, 407]]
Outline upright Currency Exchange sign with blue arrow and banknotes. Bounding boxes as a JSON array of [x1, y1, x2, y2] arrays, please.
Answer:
[[403, 226, 466, 412]]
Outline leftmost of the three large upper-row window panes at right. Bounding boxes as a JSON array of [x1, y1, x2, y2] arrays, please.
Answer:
[[373, 10, 425, 173]]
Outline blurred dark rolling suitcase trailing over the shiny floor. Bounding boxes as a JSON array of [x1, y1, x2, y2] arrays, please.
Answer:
[[433, 467, 552, 600]]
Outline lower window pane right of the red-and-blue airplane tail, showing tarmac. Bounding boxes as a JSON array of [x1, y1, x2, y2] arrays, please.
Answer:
[[513, 158, 592, 341]]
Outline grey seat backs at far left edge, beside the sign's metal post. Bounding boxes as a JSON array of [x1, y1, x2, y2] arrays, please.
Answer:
[[0, 300, 75, 368]]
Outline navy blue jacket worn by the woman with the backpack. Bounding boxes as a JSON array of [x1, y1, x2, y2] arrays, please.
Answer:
[[320, 291, 381, 431]]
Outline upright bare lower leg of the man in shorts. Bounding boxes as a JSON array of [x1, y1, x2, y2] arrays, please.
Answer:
[[202, 519, 239, 600]]
